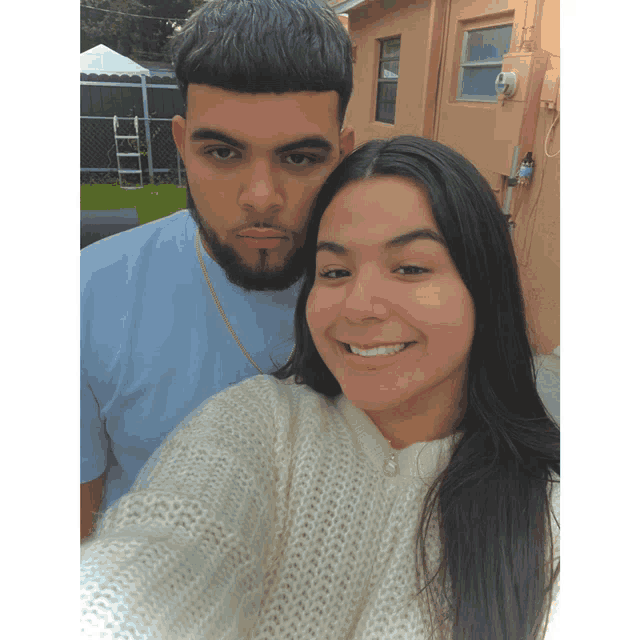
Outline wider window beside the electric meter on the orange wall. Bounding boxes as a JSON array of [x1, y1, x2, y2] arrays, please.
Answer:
[[457, 25, 512, 102]]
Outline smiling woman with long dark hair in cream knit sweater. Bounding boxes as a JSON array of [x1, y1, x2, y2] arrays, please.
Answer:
[[83, 137, 559, 640]]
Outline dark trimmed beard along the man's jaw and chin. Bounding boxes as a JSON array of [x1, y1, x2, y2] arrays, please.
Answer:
[[187, 183, 304, 291]]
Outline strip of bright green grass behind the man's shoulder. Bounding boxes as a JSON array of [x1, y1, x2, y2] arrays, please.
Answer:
[[80, 184, 187, 224]]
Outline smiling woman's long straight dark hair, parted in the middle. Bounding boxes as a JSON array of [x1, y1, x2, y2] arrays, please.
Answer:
[[273, 136, 560, 640]]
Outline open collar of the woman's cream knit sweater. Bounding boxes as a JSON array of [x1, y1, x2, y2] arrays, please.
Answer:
[[336, 395, 462, 482]]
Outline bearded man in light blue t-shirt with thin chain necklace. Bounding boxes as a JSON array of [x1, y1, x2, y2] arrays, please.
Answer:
[[81, 0, 354, 538]]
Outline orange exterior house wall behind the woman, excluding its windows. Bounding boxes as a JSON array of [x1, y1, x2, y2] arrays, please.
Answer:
[[332, 0, 560, 354]]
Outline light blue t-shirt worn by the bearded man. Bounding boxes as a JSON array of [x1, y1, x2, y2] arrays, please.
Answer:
[[80, 211, 300, 511]]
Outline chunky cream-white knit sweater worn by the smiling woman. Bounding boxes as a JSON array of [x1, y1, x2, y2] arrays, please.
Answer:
[[81, 376, 559, 640]]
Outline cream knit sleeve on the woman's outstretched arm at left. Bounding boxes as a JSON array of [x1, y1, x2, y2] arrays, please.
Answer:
[[81, 377, 277, 640]]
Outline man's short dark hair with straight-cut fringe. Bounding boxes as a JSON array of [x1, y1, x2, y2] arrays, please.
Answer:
[[171, 0, 353, 125]]
